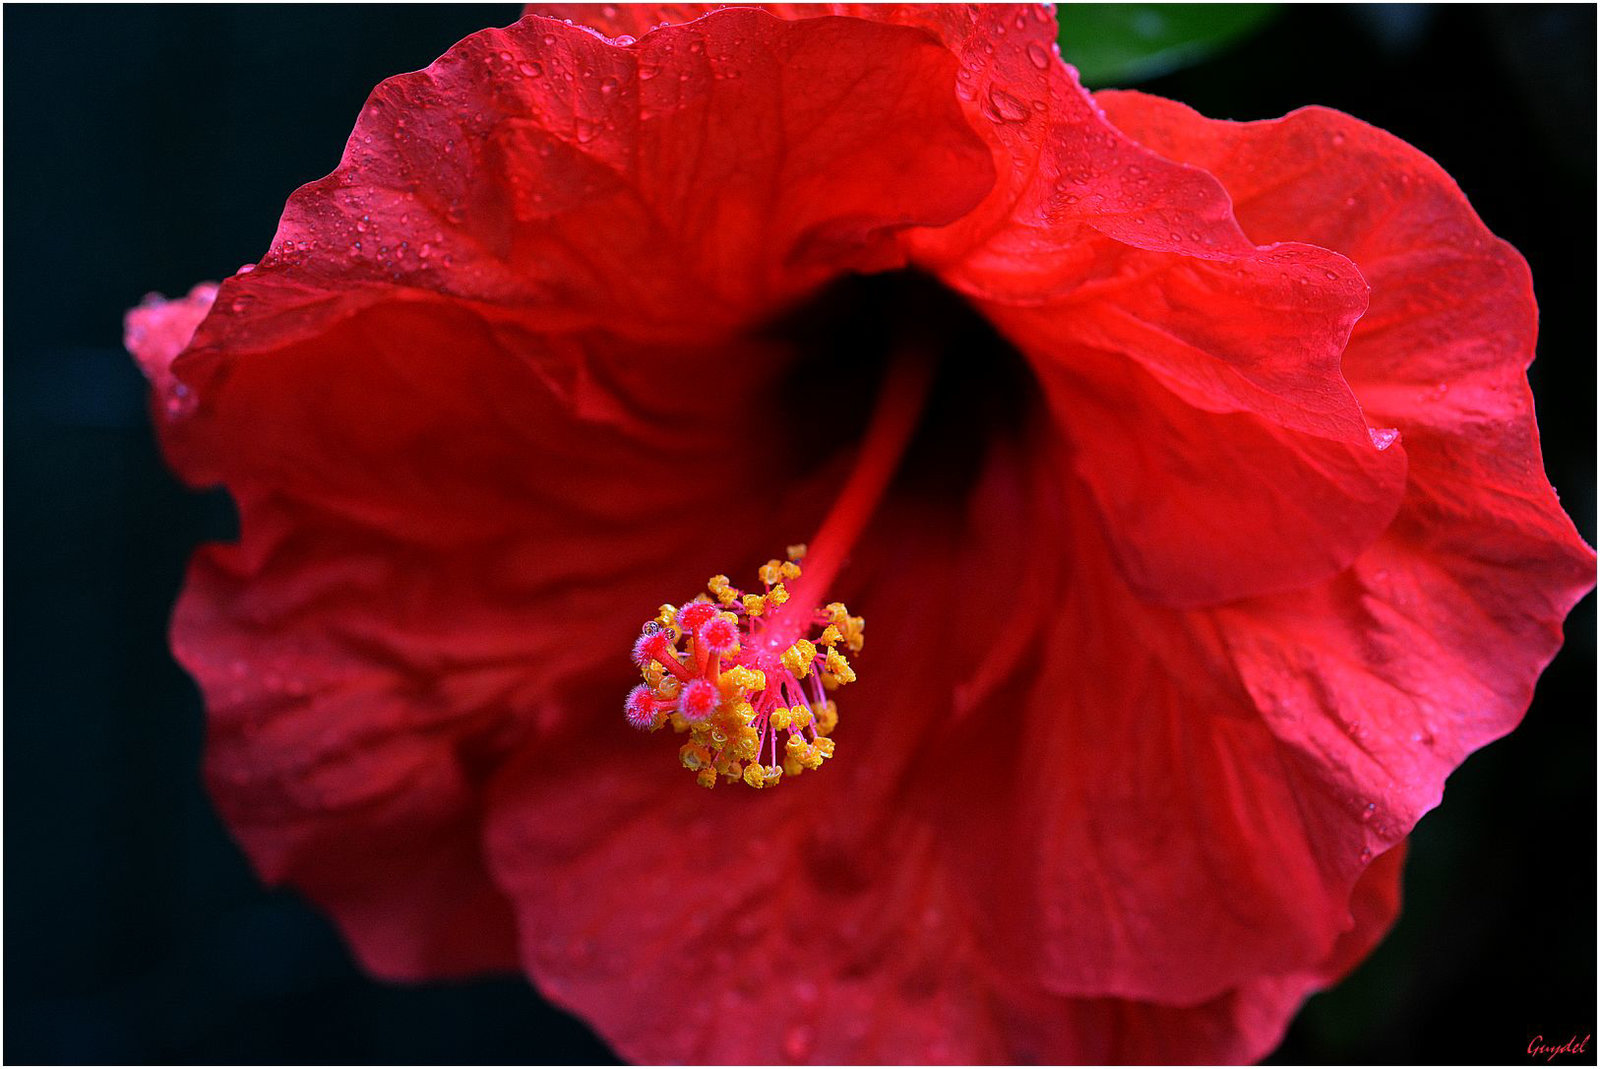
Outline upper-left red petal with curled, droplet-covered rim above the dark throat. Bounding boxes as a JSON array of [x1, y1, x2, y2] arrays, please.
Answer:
[[181, 10, 992, 389]]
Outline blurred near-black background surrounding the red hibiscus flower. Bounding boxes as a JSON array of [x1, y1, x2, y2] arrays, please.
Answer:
[[3, 5, 1595, 1063]]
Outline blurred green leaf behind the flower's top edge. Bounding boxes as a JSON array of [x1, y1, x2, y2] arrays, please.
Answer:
[[1056, 3, 1278, 90]]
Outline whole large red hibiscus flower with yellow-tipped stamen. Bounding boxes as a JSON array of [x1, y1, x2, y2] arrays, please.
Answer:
[[128, 8, 1594, 1063]]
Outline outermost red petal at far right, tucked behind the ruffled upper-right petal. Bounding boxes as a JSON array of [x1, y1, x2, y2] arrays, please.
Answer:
[[1104, 93, 1595, 832]]
